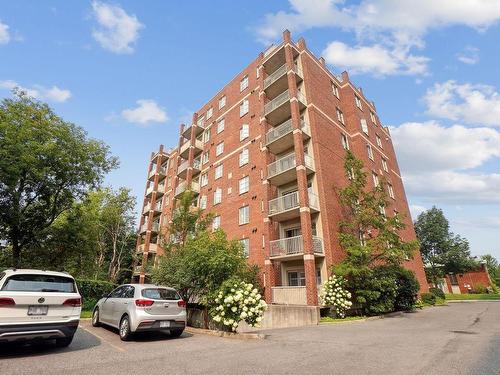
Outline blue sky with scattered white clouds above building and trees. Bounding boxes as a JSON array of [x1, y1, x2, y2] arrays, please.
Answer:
[[0, 0, 500, 258]]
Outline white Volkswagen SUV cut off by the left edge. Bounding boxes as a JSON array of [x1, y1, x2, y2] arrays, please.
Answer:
[[0, 269, 82, 347]]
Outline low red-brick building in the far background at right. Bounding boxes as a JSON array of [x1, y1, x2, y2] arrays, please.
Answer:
[[441, 264, 492, 294]]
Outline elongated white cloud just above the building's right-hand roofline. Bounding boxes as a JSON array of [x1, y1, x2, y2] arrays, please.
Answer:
[[322, 41, 429, 76]]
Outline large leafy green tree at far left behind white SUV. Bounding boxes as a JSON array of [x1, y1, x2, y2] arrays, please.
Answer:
[[0, 91, 117, 266]]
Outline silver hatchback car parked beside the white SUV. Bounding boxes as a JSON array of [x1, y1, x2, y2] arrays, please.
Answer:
[[92, 284, 186, 341]]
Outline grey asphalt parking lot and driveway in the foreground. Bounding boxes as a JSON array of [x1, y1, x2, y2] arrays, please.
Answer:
[[0, 302, 500, 375]]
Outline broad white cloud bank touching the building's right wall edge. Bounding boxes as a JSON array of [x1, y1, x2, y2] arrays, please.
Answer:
[[391, 121, 500, 204]]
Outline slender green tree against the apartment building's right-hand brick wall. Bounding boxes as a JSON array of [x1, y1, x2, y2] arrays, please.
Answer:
[[333, 151, 418, 313]]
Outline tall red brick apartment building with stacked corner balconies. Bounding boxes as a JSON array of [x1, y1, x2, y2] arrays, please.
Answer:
[[134, 31, 428, 306]]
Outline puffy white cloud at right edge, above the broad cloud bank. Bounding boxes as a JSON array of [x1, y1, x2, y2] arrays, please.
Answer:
[[423, 80, 500, 126]]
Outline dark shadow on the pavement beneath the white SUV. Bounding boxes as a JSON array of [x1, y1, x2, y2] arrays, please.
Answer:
[[0, 329, 101, 359]]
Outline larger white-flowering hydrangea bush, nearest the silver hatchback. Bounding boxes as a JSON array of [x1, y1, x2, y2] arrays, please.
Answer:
[[210, 280, 267, 331]]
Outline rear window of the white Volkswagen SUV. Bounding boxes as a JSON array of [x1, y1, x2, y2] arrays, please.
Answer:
[[2, 274, 76, 293]]
